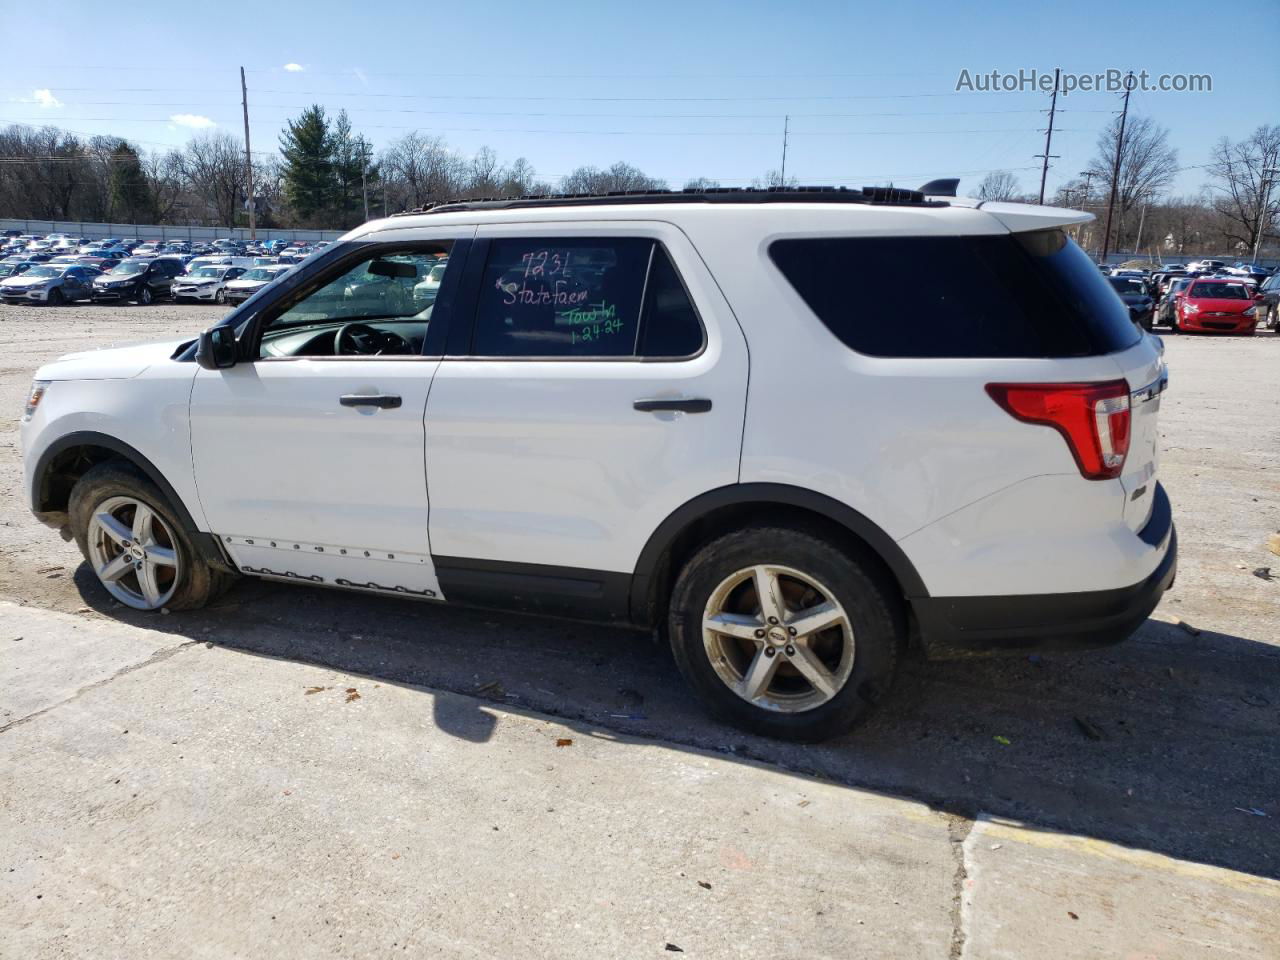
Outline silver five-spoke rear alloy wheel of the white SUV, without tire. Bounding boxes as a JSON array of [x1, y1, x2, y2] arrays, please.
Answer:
[[703, 564, 855, 713]]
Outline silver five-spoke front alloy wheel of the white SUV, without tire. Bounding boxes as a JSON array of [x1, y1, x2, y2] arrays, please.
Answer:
[[87, 497, 182, 611]]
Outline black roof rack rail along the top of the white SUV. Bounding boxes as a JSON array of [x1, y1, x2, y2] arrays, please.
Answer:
[[392, 187, 947, 216]]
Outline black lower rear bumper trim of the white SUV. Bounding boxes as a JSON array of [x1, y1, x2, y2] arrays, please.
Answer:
[[911, 485, 1178, 659]]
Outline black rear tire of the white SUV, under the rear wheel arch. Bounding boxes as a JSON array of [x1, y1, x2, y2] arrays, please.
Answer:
[[668, 526, 905, 742]]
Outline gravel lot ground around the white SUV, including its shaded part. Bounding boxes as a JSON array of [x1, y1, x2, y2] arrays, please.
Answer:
[[0, 305, 1280, 877]]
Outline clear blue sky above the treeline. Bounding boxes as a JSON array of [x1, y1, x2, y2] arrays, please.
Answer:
[[0, 0, 1280, 199]]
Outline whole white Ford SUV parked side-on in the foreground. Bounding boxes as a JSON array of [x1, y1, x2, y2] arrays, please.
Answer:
[[22, 188, 1176, 740]]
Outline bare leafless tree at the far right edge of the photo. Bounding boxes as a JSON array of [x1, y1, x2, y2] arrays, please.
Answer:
[[1208, 124, 1280, 251]]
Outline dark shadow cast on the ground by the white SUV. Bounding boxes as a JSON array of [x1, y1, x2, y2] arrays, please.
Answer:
[[74, 564, 1280, 878]]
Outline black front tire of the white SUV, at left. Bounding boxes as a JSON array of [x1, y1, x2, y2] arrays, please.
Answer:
[[68, 461, 234, 611]]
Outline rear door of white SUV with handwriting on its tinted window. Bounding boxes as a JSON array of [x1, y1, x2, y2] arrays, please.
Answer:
[[426, 221, 748, 608]]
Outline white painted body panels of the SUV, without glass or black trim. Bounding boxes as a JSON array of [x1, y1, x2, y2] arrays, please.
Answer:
[[22, 201, 1166, 609]]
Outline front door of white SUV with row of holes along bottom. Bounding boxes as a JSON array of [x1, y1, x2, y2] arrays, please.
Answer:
[[191, 237, 468, 599]]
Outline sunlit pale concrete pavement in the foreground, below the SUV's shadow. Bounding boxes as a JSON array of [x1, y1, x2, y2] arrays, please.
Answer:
[[0, 603, 1280, 960]]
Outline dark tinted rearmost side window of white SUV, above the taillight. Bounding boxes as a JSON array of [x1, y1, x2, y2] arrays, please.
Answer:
[[769, 230, 1140, 357]]
